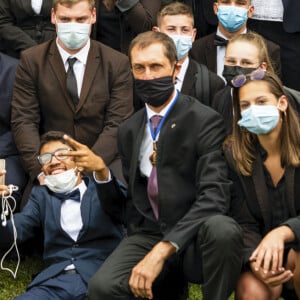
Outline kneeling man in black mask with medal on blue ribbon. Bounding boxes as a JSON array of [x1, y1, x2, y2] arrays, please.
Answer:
[[88, 32, 241, 300]]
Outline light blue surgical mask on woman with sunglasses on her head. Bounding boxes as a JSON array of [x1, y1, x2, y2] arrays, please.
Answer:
[[238, 105, 279, 134]]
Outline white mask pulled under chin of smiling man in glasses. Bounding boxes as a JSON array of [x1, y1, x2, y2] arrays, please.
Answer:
[[45, 168, 79, 193]]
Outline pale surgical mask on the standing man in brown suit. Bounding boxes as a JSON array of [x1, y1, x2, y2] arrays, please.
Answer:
[[57, 22, 91, 50]]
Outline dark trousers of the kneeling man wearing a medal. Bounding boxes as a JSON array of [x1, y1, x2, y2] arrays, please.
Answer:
[[88, 216, 242, 300]]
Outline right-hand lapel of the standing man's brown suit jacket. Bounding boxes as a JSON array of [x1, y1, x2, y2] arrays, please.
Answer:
[[76, 40, 100, 111]]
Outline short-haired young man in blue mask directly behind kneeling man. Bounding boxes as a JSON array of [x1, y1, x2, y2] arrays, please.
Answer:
[[153, 2, 224, 105]]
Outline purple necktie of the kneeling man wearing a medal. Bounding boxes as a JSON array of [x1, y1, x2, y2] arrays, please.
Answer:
[[147, 115, 162, 219]]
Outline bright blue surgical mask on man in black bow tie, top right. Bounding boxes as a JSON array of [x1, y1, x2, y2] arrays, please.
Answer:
[[217, 5, 248, 32]]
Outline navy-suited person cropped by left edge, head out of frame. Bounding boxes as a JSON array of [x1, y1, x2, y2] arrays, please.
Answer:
[[0, 52, 27, 208]]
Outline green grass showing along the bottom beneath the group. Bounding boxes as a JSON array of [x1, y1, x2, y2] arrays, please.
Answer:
[[0, 258, 234, 300]]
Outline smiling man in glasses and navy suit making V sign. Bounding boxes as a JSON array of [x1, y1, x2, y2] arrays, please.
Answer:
[[0, 131, 123, 300]]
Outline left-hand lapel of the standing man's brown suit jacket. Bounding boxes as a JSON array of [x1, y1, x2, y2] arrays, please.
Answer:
[[48, 39, 75, 111]]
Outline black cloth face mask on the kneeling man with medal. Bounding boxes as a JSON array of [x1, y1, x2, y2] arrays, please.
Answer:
[[134, 76, 174, 107]]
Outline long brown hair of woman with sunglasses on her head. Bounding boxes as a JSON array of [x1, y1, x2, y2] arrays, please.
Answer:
[[224, 72, 300, 176]]
